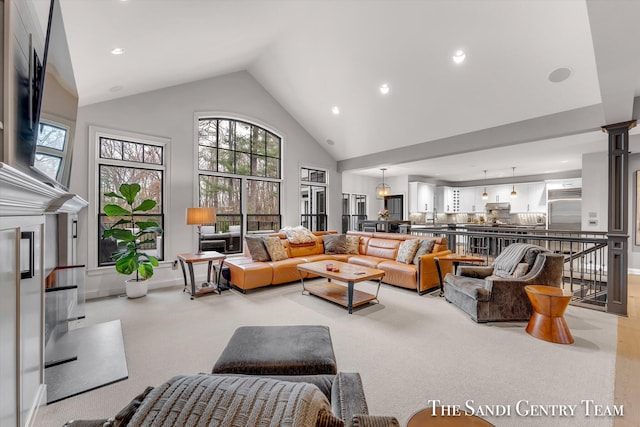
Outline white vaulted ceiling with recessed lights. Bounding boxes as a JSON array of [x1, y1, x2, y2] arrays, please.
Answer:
[[42, 0, 640, 181]]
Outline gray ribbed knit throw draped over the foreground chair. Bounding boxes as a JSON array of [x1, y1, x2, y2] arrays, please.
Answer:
[[129, 374, 331, 427]]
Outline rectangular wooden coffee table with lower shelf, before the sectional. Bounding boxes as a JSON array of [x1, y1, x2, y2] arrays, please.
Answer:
[[298, 261, 384, 314]]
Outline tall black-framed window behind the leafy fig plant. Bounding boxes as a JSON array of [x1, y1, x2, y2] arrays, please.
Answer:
[[98, 136, 165, 266]]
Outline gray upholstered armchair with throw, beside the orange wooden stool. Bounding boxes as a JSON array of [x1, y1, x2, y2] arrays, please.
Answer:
[[444, 243, 564, 323]]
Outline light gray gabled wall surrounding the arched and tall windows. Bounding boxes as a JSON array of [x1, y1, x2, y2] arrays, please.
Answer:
[[70, 71, 342, 297]]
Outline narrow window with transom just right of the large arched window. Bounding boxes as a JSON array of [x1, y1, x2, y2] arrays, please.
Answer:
[[300, 167, 327, 231]]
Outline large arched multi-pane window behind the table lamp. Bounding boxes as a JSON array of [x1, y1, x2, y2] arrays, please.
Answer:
[[198, 117, 282, 250]]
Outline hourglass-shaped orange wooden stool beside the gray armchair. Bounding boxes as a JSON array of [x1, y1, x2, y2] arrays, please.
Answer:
[[524, 285, 573, 344]]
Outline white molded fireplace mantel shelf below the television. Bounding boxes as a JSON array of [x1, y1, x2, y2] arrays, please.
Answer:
[[0, 162, 89, 216]]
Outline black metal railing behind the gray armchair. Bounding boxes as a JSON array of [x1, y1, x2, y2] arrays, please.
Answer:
[[411, 224, 607, 311]]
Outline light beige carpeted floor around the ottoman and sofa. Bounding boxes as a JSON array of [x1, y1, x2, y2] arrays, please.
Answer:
[[31, 283, 618, 426]]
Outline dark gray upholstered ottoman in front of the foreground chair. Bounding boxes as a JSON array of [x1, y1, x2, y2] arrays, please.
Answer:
[[212, 325, 338, 375]]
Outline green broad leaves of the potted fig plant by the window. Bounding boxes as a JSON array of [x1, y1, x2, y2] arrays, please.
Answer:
[[102, 183, 162, 280]]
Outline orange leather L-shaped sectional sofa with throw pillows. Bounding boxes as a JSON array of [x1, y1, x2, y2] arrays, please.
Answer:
[[224, 231, 452, 294]]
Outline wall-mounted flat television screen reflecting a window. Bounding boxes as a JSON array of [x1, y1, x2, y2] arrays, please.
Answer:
[[25, 0, 78, 190]]
